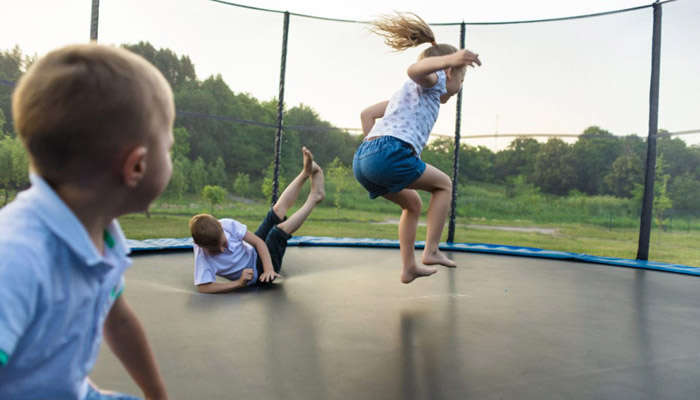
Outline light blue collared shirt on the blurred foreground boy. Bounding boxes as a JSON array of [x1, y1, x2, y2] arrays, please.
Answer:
[[0, 175, 131, 399]]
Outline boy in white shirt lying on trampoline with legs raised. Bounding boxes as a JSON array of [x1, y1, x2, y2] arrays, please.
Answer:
[[190, 147, 326, 293]]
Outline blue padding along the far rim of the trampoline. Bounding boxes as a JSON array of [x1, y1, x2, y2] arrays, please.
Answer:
[[127, 236, 700, 276]]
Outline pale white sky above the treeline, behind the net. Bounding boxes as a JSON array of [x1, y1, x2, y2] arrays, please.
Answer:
[[0, 0, 700, 150]]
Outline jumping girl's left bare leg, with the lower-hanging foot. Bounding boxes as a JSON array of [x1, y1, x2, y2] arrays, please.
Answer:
[[384, 189, 437, 283]]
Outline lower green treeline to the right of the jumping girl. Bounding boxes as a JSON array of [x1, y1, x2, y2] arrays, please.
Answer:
[[423, 130, 700, 212]]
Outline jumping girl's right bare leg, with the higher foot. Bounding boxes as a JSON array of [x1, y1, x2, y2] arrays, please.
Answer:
[[408, 164, 457, 268]]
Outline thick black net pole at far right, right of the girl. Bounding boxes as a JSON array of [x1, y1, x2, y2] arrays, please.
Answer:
[[637, 0, 661, 261]]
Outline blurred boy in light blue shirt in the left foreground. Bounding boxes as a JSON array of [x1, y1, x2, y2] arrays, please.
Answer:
[[0, 44, 174, 400]]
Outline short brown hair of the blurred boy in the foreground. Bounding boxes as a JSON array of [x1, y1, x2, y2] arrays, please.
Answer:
[[12, 44, 174, 182]]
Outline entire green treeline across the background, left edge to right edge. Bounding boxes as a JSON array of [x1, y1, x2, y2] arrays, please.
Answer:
[[0, 42, 700, 212]]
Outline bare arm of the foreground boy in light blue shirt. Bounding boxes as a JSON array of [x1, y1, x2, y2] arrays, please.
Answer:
[[104, 294, 168, 400]]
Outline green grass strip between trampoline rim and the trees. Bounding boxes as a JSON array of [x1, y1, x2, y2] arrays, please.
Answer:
[[120, 199, 700, 266]]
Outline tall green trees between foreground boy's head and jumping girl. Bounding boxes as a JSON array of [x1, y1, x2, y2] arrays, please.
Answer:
[[124, 42, 359, 194]]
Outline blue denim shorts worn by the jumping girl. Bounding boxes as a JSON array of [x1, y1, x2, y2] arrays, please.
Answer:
[[352, 136, 425, 199]]
